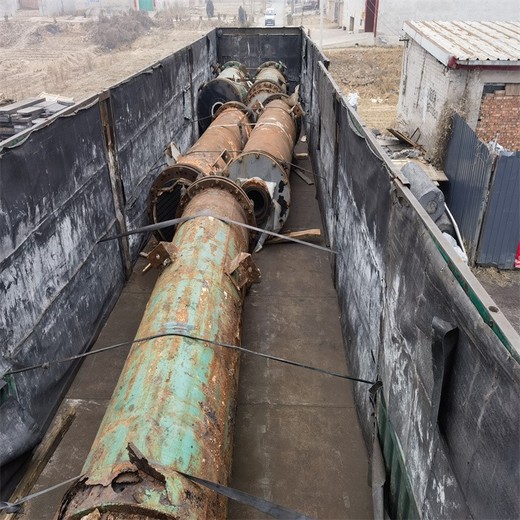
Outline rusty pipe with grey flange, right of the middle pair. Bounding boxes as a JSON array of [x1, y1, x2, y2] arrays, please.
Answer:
[[228, 96, 302, 246]]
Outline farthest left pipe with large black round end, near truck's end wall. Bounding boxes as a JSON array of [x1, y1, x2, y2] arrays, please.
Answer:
[[197, 61, 251, 134]]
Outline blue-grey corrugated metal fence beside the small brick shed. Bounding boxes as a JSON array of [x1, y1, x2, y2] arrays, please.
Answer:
[[444, 114, 520, 269]]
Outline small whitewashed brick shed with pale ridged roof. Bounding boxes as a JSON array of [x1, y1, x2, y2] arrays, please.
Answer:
[[397, 22, 520, 161]]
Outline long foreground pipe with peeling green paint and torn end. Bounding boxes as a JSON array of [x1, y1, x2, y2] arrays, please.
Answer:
[[58, 187, 258, 520]]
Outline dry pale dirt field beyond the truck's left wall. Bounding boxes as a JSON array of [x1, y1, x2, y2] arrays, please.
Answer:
[[0, 11, 216, 101]]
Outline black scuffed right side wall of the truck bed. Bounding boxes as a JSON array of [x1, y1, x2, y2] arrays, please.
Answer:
[[302, 34, 520, 518]]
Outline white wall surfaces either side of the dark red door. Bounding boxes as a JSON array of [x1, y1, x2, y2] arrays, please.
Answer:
[[343, 0, 520, 43]]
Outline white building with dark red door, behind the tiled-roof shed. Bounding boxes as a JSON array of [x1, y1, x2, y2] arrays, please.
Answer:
[[342, 0, 520, 43]]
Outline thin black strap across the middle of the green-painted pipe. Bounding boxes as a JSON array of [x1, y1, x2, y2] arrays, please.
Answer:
[[4, 332, 375, 385]]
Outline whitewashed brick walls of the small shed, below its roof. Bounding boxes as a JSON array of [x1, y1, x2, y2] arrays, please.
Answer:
[[397, 40, 518, 163]]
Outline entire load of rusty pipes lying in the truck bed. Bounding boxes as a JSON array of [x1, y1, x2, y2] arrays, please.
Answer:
[[58, 62, 302, 519]]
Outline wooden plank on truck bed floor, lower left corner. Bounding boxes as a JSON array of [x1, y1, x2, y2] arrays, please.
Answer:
[[0, 402, 78, 520]]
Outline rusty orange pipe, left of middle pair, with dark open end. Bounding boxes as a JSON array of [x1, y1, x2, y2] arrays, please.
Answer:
[[149, 103, 251, 240]]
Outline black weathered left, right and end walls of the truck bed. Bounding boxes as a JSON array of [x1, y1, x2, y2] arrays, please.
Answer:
[[0, 28, 520, 518]]
